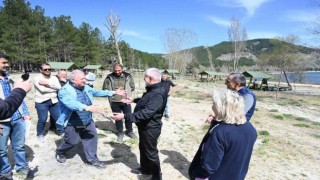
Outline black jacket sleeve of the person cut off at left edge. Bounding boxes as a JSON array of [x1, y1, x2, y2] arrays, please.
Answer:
[[0, 88, 27, 120]]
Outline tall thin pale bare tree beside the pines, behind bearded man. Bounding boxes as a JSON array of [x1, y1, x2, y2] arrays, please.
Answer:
[[105, 11, 123, 64]]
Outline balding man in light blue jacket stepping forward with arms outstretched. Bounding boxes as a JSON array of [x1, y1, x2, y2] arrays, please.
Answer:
[[56, 70, 125, 169]]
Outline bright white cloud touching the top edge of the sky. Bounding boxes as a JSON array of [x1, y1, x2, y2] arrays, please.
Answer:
[[219, 0, 272, 16]]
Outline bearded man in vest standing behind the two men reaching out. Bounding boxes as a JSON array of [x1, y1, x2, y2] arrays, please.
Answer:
[[102, 63, 137, 142]]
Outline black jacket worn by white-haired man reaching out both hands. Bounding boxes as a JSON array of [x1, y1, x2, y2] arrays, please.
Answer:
[[125, 83, 167, 129]]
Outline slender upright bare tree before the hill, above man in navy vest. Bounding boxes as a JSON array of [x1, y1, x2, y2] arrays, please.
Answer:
[[228, 17, 247, 71]]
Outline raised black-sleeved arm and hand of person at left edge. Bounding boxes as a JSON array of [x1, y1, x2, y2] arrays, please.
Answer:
[[0, 81, 31, 120]]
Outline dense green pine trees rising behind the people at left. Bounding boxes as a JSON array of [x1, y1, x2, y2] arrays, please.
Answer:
[[0, 0, 165, 70]]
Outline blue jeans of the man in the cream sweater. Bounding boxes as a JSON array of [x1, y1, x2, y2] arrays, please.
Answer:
[[36, 100, 64, 136]]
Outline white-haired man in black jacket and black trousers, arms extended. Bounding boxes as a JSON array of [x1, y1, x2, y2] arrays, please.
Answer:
[[112, 68, 167, 180]]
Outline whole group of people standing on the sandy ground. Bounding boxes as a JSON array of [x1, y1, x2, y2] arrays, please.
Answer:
[[0, 50, 257, 180]]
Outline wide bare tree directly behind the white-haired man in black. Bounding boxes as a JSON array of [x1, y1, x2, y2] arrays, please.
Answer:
[[163, 28, 196, 74]]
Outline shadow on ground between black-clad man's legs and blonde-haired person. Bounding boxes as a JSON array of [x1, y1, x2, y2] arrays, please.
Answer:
[[160, 150, 190, 179]]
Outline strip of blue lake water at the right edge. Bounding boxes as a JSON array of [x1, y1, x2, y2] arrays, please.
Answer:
[[274, 72, 320, 84]]
